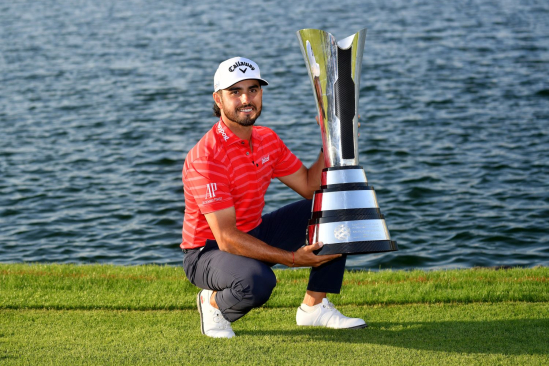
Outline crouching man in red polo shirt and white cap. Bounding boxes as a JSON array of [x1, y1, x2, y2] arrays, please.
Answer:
[[181, 57, 366, 338]]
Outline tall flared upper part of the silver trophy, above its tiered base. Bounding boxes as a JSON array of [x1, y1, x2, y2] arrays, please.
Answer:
[[297, 29, 366, 167]]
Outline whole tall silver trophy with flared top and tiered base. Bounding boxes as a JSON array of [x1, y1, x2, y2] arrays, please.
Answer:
[[297, 29, 398, 254]]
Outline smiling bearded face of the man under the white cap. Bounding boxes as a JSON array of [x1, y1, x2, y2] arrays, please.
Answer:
[[214, 79, 263, 126]]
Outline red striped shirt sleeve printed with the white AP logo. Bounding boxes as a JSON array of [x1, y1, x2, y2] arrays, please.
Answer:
[[183, 159, 234, 214]]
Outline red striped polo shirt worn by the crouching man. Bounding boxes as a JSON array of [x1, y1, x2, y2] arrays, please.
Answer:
[[181, 120, 302, 249]]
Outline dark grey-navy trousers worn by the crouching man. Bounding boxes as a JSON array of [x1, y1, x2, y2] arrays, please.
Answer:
[[183, 200, 346, 322]]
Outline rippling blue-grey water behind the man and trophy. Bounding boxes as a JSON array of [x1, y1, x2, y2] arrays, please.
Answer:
[[0, 0, 549, 269]]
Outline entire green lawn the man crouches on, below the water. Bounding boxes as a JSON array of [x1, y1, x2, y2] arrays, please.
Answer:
[[0, 264, 549, 365]]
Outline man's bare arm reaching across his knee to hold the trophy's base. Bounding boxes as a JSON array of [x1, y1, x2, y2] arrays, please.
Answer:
[[205, 207, 341, 267]]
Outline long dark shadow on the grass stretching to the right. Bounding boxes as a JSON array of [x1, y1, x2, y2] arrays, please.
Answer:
[[237, 319, 549, 355]]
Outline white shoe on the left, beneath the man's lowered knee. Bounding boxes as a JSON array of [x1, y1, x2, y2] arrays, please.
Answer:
[[196, 290, 234, 338]]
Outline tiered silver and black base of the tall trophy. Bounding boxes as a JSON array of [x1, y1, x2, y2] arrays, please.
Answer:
[[307, 166, 398, 254]]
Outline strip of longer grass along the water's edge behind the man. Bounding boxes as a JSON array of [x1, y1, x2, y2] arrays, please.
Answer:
[[0, 264, 549, 310]]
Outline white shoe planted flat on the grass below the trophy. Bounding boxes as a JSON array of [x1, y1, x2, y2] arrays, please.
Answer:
[[295, 298, 368, 329]]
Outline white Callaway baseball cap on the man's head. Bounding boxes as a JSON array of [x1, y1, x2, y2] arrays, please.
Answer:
[[214, 57, 269, 92]]
